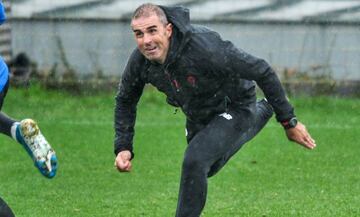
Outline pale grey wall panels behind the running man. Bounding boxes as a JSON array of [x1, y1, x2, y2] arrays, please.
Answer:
[[11, 19, 360, 80]]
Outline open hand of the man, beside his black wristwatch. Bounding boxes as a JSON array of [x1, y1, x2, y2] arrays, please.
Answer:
[[285, 122, 316, 149]]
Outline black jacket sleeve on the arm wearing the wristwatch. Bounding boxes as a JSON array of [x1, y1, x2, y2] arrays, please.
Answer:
[[218, 34, 295, 122]]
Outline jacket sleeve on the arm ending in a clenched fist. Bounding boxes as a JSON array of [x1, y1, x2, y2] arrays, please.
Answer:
[[114, 50, 145, 158]]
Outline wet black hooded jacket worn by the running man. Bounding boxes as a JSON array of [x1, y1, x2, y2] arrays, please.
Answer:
[[115, 6, 294, 157]]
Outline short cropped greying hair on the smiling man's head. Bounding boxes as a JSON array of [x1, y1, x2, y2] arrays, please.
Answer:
[[131, 3, 168, 25]]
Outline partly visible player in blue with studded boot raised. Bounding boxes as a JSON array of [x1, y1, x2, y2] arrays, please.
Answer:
[[0, 1, 57, 217]]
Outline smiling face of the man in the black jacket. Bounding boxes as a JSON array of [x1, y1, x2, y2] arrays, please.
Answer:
[[131, 13, 172, 64]]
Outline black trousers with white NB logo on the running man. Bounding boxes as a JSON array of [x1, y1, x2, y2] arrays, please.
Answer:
[[176, 100, 273, 217]]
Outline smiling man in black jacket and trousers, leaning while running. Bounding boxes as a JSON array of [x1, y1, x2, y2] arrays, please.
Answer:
[[115, 4, 316, 217]]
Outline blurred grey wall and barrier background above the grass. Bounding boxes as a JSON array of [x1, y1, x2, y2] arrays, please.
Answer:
[[0, 0, 360, 96]]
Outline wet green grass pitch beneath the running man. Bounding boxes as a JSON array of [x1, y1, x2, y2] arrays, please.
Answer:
[[0, 87, 360, 217]]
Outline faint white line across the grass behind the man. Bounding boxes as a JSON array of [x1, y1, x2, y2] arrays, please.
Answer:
[[42, 120, 360, 130]]
